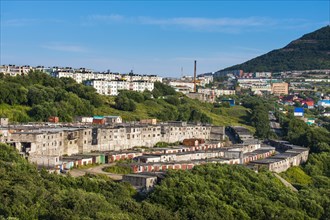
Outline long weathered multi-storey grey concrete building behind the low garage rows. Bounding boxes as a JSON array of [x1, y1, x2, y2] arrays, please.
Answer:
[[0, 122, 224, 165]]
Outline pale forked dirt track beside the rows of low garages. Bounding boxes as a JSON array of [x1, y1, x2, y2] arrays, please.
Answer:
[[70, 163, 123, 180]]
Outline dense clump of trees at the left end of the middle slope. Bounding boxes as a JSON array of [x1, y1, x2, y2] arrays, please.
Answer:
[[0, 71, 103, 122]]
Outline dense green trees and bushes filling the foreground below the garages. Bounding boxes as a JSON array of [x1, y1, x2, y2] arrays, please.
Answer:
[[0, 144, 330, 220]]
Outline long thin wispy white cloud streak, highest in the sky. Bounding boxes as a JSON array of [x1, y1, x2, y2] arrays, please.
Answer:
[[82, 14, 324, 33]]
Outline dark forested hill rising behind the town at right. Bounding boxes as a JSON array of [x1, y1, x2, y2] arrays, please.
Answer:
[[225, 26, 330, 72]]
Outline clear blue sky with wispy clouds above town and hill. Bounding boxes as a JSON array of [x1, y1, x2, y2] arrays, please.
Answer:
[[0, 0, 330, 77]]
